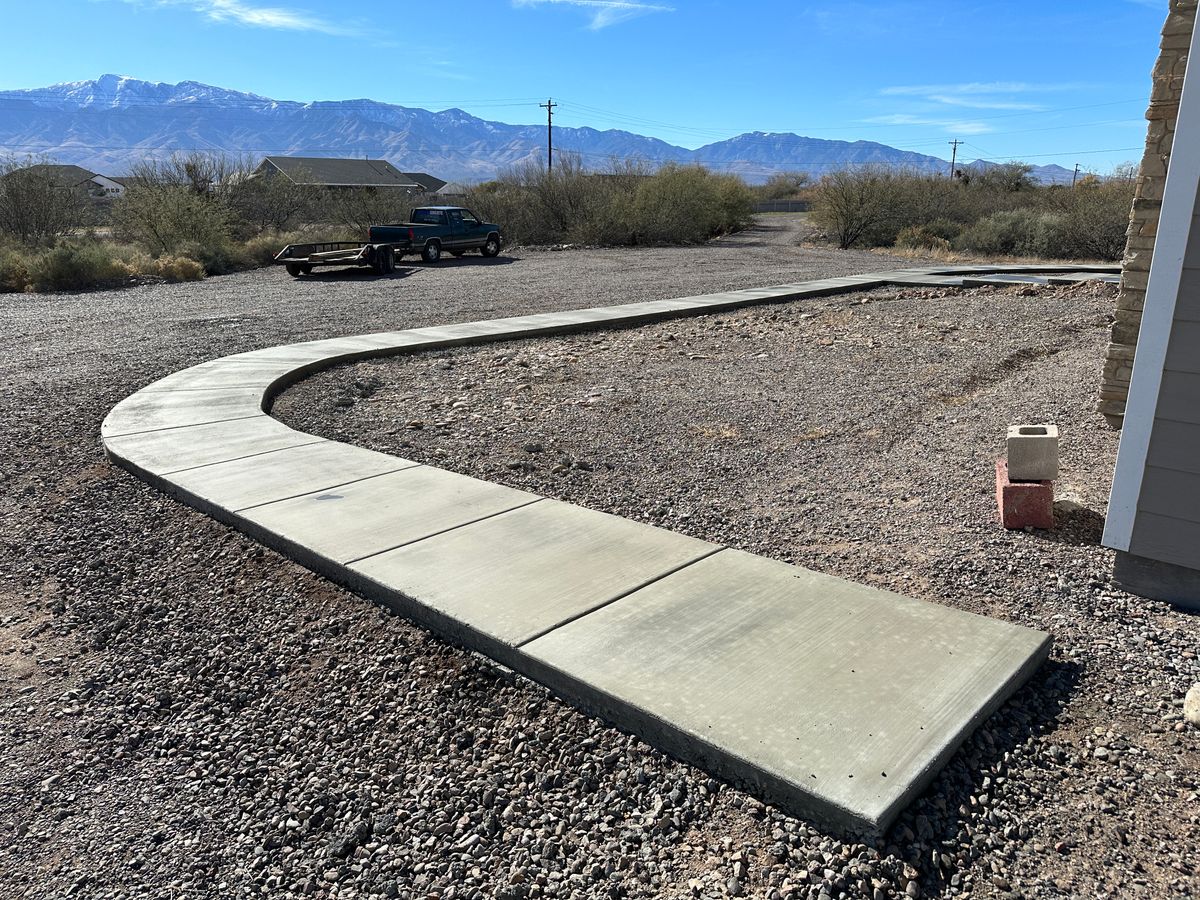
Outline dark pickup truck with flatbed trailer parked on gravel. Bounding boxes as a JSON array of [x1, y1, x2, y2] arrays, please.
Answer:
[[275, 206, 500, 277]]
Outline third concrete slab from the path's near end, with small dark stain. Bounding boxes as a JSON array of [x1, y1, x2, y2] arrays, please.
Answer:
[[240, 466, 541, 563]]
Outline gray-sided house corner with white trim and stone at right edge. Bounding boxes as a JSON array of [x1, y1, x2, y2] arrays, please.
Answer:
[[1102, 7, 1200, 610]]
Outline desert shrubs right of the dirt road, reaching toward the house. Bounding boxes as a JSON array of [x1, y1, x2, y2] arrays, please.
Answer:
[[809, 163, 1134, 259]]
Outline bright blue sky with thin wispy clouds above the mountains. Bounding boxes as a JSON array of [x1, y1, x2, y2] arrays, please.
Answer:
[[0, 0, 1168, 172]]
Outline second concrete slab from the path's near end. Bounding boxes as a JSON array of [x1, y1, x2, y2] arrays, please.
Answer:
[[350, 500, 720, 646]]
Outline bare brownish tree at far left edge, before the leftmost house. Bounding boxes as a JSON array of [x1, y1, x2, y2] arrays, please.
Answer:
[[0, 156, 89, 245]]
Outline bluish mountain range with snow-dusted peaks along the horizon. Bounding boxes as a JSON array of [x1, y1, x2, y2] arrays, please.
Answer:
[[0, 74, 1072, 182]]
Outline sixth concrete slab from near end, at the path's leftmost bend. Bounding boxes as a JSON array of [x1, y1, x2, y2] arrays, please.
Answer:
[[100, 388, 263, 438]]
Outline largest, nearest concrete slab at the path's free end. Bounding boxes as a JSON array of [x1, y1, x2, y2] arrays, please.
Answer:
[[522, 550, 1050, 830]]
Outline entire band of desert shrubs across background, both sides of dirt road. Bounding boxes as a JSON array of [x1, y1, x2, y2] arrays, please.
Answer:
[[0, 152, 1134, 292]]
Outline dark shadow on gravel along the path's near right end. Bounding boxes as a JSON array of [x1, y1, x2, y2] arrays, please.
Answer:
[[876, 660, 1084, 896]]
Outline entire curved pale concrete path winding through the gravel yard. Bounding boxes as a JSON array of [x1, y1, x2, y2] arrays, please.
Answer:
[[101, 266, 1115, 832]]
